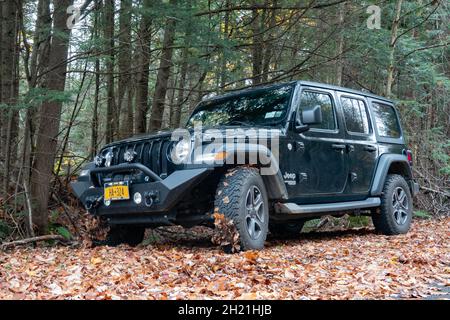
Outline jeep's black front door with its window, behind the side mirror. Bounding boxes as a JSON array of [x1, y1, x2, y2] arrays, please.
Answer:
[[288, 87, 348, 203]]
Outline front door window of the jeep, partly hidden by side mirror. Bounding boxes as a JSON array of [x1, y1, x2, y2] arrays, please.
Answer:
[[299, 91, 336, 130]]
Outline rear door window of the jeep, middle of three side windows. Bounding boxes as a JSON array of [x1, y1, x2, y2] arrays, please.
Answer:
[[341, 97, 370, 134]]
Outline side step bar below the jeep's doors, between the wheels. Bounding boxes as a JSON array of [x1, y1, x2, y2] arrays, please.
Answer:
[[275, 198, 381, 215]]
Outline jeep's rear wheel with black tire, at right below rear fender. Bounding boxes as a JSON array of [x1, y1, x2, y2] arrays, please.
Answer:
[[372, 174, 413, 235]]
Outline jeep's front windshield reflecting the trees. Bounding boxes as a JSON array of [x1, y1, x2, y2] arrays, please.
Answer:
[[187, 85, 294, 127]]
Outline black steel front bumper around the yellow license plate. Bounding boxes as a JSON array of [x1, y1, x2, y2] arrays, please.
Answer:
[[71, 164, 211, 217]]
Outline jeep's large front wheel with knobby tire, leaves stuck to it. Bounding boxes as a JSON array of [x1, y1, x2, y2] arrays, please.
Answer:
[[214, 167, 269, 251]]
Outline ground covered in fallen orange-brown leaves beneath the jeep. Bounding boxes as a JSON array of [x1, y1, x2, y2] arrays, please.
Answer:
[[0, 218, 450, 299]]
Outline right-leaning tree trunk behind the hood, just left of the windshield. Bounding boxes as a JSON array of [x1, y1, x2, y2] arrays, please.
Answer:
[[149, 0, 177, 131]]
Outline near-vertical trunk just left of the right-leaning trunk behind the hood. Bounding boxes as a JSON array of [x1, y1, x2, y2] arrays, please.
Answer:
[[134, 0, 153, 134]]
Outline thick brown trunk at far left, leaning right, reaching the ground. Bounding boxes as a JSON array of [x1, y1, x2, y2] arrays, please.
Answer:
[[31, 0, 73, 234]]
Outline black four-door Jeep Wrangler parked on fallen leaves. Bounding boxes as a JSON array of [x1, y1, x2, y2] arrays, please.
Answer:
[[72, 81, 419, 250]]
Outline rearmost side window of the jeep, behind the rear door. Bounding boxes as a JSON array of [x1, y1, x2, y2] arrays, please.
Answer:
[[372, 102, 401, 138]]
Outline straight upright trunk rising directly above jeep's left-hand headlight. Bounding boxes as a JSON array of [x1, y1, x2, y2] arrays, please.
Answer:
[[104, 0, 118, 143]]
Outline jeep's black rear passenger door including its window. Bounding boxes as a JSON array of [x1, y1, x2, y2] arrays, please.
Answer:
[[337, 92, 379, 197]]
